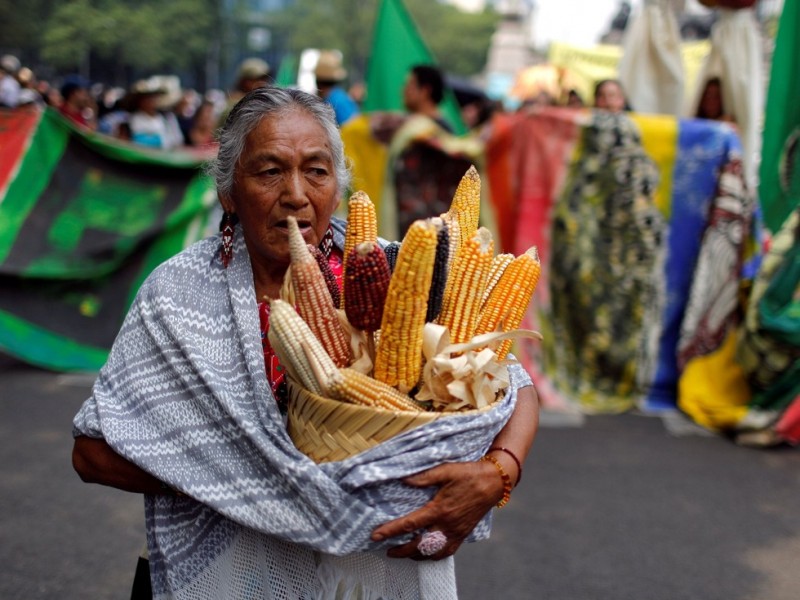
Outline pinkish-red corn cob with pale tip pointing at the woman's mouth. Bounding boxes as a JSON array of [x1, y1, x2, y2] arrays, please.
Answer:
[[288, 217, 350, 367]]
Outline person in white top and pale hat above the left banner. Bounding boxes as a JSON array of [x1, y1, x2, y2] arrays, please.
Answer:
[[128, 79, 183, 150]]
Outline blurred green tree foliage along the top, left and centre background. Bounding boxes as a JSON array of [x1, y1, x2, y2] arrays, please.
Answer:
[[0, 0, 498, 88]]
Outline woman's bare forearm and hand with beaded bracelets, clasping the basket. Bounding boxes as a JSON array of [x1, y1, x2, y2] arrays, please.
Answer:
[[372, 386, 539, 560]]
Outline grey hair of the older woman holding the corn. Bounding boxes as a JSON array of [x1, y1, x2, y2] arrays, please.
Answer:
[[206, 87, 351, 196]]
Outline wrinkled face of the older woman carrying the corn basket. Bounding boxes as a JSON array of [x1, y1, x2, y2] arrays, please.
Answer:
[[221, 109, 339, 269]]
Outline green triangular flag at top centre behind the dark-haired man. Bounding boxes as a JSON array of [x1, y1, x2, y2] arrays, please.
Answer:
[[364, 0, 466, 134]]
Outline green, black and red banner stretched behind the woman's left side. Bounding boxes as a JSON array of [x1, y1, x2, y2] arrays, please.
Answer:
[[0, 109, 216, 370]]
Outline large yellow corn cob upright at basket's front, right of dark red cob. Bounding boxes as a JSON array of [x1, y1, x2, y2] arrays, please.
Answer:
[[374, 219, 438, 393]]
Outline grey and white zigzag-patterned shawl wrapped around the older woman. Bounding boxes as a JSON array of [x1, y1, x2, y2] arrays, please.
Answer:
[[74, 220, 530, 600]]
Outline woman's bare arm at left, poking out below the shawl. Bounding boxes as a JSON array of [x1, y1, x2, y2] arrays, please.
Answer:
[[72, 435, 175, 494]]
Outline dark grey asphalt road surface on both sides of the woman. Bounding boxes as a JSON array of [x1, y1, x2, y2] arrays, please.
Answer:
[[0, 360, 800, 600]]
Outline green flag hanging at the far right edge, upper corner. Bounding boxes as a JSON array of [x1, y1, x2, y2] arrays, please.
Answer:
[[758, 0, 800, 233]]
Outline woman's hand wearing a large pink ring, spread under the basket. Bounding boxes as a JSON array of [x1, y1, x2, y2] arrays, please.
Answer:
[[372, 461, 503, 560]]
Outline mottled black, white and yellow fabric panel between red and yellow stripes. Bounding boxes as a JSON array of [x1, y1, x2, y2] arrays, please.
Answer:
[[542, 111, 665, 412]]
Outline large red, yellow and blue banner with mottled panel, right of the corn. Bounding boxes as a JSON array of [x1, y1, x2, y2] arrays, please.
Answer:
[[487, 109, 752, 412]]
